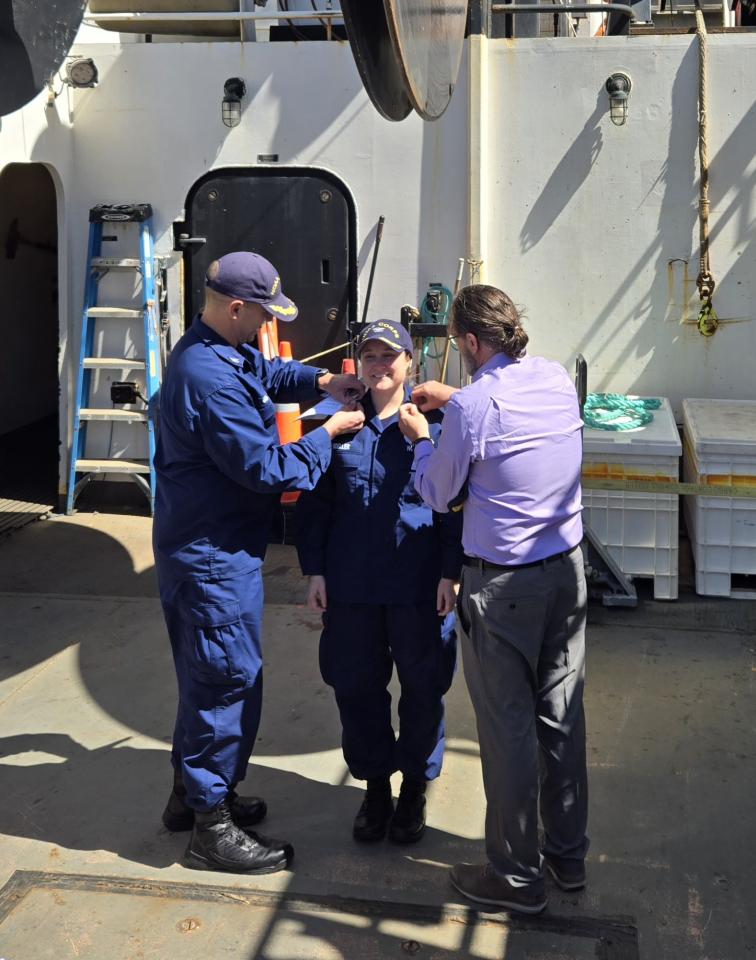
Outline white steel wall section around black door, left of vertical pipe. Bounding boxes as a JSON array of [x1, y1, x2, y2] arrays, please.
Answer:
[[59, 42, 466, 472]]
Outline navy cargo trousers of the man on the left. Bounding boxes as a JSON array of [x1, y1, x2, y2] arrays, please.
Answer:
[[160, 570, 263, 811]]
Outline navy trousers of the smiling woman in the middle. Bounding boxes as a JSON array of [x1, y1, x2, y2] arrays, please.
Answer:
[[320, 600, 456, 780]]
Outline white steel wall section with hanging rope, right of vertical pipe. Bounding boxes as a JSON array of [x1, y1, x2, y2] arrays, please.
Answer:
[[487, 34, 756, 415]]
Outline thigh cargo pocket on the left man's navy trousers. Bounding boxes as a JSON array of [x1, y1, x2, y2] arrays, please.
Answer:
[[181, 601, 254, 686]]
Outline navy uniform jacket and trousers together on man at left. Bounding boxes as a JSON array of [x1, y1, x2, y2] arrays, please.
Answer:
[[153, 317, 331, 810]]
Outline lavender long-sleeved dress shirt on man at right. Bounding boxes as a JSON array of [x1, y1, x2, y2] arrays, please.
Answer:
[[415, 353, 583, 565]]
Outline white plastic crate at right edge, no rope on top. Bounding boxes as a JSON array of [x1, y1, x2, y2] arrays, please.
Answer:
[[683, 399, 756, 599]]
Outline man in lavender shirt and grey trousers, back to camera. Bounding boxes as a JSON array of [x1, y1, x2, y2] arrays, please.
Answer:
[[400, 284, 588, 914]]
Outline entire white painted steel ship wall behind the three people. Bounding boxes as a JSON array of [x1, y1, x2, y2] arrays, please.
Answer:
[[0, 34, 756, 488]]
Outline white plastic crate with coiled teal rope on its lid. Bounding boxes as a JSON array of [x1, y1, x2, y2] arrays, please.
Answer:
[[583, 398, 682, 600]]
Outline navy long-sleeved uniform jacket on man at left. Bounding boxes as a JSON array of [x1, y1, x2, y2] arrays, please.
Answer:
[[153, 317, 331, 582]]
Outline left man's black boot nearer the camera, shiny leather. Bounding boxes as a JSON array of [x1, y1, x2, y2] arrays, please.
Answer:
[[181, 800, 294, 874]]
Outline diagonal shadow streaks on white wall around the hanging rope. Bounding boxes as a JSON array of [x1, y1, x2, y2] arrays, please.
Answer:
[[560, 44, 756, 396]]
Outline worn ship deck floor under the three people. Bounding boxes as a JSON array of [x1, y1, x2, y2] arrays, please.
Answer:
[[0, 513, 756, 960]]
